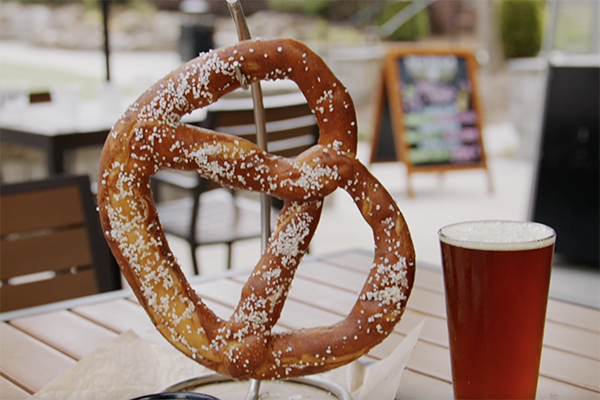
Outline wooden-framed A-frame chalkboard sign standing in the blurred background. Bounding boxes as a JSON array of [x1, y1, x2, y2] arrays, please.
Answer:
[[370, 47, 492, 197]]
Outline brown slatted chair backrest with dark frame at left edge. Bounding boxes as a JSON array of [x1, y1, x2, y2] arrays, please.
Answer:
[[0, 176, 121, 312]]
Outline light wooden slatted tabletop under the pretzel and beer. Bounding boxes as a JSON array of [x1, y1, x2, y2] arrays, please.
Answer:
[[0, 251, 600, 400]]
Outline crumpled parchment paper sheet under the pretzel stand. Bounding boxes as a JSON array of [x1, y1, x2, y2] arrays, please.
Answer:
[[31, 320, 425, 400]]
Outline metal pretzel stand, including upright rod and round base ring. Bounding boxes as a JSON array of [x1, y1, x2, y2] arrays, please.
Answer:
[[162, 0, 352, 400]]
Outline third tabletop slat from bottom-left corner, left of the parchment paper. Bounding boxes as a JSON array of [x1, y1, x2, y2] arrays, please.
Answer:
[[10, 310, 117, 360]]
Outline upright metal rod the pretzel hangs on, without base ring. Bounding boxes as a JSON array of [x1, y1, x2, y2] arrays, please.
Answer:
[[227, 0, 271, 400]]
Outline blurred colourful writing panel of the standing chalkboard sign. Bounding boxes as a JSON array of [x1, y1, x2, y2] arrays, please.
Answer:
[[397, 55, 481, 165]]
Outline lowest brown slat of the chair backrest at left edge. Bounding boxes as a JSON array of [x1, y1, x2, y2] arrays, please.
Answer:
[[0, 269, 98, 312]]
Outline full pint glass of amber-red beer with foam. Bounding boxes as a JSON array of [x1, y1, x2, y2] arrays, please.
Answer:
[[439, 221, 556, 400]]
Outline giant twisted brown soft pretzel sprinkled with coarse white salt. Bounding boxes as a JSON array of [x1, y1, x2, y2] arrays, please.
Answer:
[[98, 39, 415, 379]]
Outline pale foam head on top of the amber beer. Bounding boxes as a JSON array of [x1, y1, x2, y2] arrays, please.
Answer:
[[439, 221, 556, 251]]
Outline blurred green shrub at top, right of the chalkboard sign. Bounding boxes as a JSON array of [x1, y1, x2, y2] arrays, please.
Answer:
[[498, 0, 545, 58]]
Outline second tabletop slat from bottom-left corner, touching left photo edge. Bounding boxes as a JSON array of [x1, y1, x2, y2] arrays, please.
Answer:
[[0, 322, 75, 393]]
